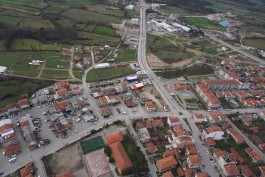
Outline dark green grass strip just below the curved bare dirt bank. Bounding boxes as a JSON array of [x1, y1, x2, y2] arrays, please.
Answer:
[[156, 64, 214, 79]]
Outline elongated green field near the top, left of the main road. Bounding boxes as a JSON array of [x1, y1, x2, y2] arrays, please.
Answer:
[[61, 9, 121, 24]]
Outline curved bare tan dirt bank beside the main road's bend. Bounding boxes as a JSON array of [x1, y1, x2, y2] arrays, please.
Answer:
[[147, 54, 192, 69]]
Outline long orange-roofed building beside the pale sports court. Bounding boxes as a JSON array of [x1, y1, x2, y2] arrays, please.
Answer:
[[109, 142, 133, 174]]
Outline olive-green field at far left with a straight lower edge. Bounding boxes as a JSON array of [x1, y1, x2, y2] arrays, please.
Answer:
[[9, 38, 63, 51]]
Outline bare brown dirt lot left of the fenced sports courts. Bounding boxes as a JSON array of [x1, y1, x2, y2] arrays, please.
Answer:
[[50, 143, 88, 177]]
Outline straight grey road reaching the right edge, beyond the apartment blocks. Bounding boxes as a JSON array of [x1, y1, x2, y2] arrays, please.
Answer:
[[204, 31, 265, 64]]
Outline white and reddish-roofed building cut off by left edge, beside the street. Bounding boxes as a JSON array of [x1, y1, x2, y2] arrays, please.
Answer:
[[0, 119, 15, 140]]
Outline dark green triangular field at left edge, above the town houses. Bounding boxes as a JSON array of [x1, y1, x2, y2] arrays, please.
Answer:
[[0, 77, 53, 108]]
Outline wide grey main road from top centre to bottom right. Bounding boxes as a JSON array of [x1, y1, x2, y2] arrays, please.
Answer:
[[138, 0, 219, 177]]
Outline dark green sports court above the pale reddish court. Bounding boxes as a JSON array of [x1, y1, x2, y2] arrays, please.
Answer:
[[79, 136, 105, 154]]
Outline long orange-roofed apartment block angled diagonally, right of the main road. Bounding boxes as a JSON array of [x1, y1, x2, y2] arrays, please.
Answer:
[[196, 83, 221, 109]]
